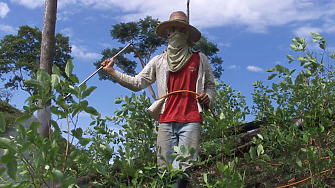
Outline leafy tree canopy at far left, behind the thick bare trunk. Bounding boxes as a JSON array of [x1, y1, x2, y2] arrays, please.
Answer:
[[0, 25, 72, 94]]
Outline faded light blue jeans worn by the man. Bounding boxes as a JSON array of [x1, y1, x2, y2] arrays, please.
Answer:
[[157, 122, 201, 170]]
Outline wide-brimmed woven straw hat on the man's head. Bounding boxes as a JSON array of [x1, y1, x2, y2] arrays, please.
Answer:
[[156, 11, 201, 42]]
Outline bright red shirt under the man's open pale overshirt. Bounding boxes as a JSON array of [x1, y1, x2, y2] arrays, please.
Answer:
[[159, 53, 202, 123]]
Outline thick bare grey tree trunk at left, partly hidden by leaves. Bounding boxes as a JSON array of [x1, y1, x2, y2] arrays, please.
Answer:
[[37, 0, 57, 137]]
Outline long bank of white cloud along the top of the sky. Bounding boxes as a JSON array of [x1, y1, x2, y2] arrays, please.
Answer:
[[11, 0, 335, 32]]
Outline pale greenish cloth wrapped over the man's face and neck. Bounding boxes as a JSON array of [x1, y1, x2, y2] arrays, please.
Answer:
[[165, 31, 192, 72]]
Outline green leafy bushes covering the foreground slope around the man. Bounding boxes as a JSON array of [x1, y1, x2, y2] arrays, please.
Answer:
[[0, 33, 335, 187]]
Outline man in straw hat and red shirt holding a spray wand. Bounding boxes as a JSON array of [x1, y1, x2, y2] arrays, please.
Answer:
[[101, 11, 216, 187]]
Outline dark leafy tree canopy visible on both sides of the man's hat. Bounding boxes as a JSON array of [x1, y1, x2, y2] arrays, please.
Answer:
[[94, 16, 223, 80]]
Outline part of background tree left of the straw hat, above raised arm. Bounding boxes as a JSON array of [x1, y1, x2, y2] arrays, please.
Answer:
[[94, 16, 166, 80]]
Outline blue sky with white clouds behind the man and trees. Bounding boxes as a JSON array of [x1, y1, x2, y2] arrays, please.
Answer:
[[0, 0, 335, 129]]
